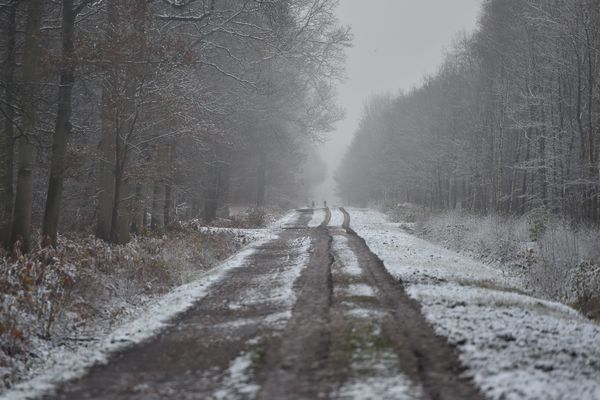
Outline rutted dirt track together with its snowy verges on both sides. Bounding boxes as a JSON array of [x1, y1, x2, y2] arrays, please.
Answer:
[[7, 209, 600, 400]]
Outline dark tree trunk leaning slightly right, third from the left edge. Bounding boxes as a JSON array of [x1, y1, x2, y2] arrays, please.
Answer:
[[42, 0, 75, 246]]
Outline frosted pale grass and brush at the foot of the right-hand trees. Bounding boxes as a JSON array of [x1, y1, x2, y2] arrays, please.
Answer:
[[412, 206, 600, 317]]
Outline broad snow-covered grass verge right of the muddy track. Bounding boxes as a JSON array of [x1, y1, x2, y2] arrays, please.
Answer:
[[349, 209, 600, 399]]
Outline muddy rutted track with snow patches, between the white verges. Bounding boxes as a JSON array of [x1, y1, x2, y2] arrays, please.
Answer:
[[45, 209, 481, 399]]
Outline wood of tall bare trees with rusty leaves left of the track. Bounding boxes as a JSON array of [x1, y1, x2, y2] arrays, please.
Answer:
[[0, 0, 350, 250]]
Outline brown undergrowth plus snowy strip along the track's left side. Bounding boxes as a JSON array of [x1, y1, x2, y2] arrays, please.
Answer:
[[0, 213, 296, 398]]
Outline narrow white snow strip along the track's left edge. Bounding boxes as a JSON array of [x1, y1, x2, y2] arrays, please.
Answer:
[[0, 212, 297, 400]]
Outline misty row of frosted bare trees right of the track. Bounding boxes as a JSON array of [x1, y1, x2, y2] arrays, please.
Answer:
[[338, 0, 600, 223]]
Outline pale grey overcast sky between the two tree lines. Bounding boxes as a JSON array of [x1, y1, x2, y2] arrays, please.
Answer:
[[315, 0, 482, 203]]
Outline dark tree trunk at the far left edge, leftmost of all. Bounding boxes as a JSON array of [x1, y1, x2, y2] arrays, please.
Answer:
[[0, 3, 17, 246]]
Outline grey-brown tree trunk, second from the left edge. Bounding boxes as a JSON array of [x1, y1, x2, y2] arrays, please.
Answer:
[[12, 0, 44, 251]]
